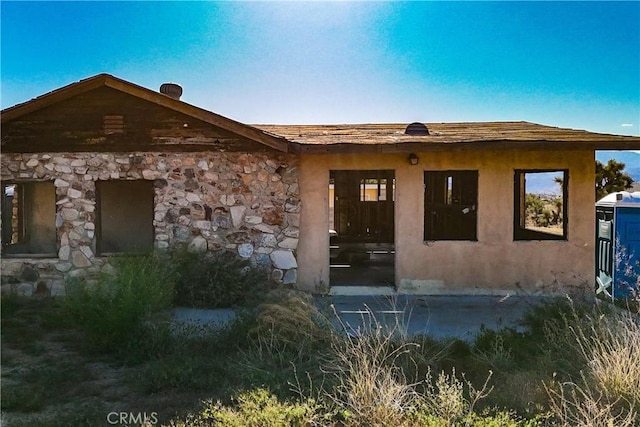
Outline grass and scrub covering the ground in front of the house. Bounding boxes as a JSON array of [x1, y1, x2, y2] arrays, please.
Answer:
[[2, 255, 640, 427]]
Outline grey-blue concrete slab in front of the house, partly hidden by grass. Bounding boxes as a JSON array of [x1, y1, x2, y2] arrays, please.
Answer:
[[173, 295, 550, 342]]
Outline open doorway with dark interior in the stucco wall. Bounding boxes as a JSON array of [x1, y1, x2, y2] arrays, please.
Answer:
[[329, 170, 396, 286]]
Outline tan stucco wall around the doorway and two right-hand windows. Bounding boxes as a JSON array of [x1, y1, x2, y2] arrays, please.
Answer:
[[298, 150, 595, 294]]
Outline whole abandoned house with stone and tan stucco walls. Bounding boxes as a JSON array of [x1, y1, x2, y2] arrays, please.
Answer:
[[1, 74, 640, 295]]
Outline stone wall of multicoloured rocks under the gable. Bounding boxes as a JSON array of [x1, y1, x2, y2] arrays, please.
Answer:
[[1, 152, 300, 295]]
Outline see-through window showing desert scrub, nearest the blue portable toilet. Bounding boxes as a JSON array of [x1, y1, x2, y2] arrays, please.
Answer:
[[513, 170, 569, 240]]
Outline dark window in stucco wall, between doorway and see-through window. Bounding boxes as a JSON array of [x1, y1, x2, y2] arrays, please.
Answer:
[[424, 171, 478, 241]]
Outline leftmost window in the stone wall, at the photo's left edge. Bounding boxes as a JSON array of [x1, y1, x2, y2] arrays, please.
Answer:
[[2, 182, 57, 255]]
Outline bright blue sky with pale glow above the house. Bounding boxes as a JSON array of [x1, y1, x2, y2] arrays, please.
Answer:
[[0, 1, 640, 135]]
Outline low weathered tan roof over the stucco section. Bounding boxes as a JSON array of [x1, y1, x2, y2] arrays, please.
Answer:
[[254, 122, 640, 152]]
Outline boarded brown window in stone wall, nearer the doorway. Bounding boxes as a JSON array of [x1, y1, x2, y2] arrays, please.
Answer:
[[96, 180, 154, 255]]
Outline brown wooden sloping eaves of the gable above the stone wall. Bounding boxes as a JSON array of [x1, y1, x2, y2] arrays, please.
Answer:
[[0, 74, 291, 152]]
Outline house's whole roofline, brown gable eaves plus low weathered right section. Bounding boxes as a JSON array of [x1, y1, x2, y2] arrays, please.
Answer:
[[0, 74, 640, 154]]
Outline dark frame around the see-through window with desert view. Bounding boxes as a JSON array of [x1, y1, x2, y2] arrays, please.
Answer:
[[513, 168, 569, 241]]
